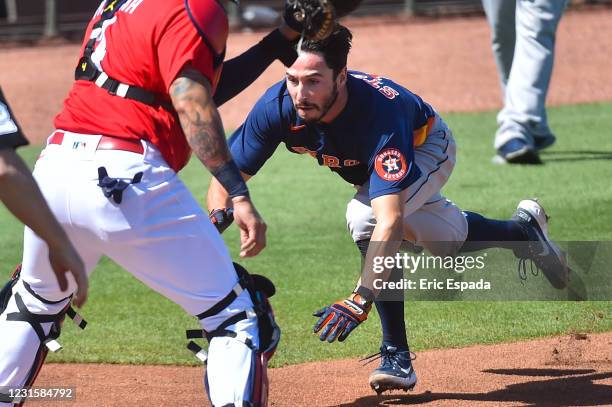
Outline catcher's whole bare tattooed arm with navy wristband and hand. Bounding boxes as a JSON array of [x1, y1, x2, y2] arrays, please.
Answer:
[[170, 66, 266, 257]]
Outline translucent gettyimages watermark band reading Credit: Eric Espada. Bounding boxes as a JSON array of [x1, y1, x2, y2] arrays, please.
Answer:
[[361, 241, 612, 301]]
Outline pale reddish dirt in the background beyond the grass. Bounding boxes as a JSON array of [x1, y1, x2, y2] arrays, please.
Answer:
[[0, 8, 612, 143]]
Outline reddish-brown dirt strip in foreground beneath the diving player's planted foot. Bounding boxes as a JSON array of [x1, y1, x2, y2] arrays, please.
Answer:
[[33, 333, 612, 407]]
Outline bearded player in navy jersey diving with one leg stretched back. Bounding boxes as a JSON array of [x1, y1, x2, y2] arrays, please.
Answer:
[[208, 25, 568, 392]]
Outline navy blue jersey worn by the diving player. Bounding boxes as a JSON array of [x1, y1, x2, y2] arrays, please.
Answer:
[[229, 71, 435, 199]]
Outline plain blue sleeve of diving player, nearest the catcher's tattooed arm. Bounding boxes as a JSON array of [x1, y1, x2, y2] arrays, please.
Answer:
[[228, 98, 281, 176]]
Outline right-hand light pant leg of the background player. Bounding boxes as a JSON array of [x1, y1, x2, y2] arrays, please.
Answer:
[[495, 0, 566, 148]]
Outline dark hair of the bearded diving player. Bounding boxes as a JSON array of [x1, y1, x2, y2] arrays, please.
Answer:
[[299, 24, 353, 79]]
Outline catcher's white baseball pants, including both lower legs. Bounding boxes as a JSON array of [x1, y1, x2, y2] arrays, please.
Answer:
[[0, 132, 258, 405]]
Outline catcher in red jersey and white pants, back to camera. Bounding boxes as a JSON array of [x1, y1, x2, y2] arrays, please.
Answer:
[[0, 0, 358, 407]]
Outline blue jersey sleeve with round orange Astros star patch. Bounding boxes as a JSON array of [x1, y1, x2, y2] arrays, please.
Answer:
[[369, 127, 419, 199]]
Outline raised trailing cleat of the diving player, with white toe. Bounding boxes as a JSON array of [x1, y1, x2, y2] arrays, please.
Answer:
[[512, 199, 570, 290]]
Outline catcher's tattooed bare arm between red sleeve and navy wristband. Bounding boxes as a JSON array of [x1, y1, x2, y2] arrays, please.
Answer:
[[170, 69, 231, 171]]
